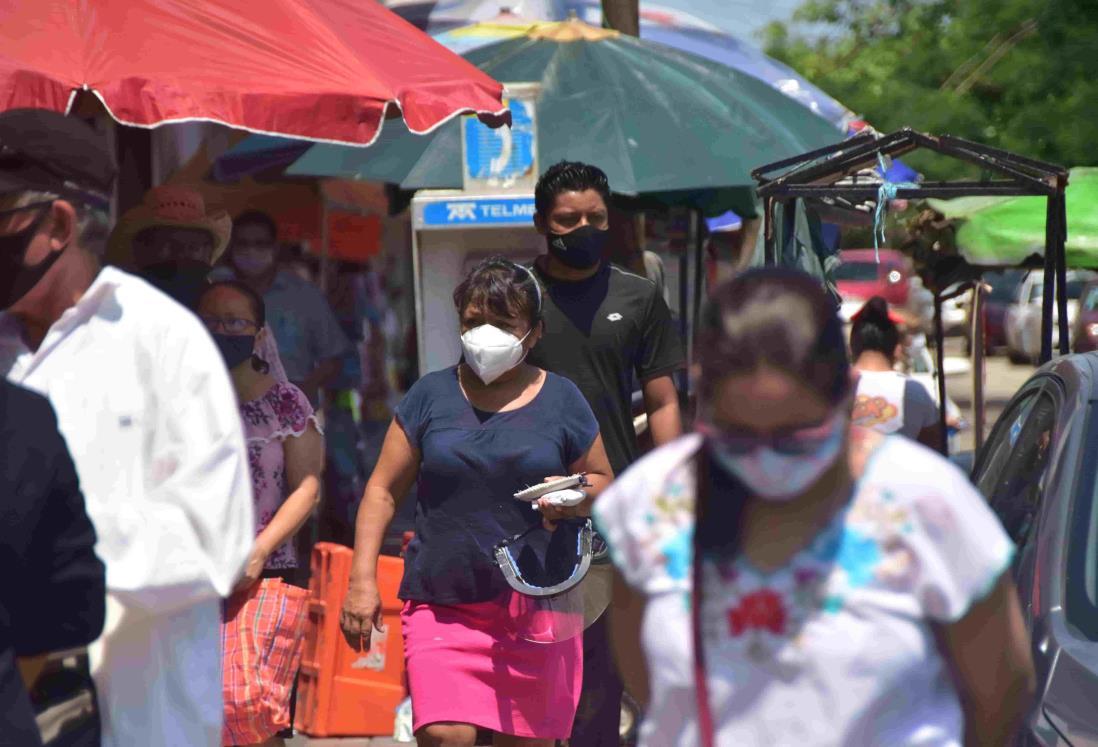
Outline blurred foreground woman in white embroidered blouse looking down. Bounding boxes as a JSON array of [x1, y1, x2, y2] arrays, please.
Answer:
[[594, 269, 1033, 747]]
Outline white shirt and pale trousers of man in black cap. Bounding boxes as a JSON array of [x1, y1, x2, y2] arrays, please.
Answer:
[[0, 267, 255, 747]]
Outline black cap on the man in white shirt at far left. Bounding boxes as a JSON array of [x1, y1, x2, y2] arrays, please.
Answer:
[[0, 109, 117, 208]]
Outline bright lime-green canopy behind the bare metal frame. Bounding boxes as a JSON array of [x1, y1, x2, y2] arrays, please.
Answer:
[[927, 168, 1098, 268]]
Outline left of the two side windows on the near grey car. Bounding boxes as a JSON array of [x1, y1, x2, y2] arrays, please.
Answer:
[[985, 390, 1056, 547]]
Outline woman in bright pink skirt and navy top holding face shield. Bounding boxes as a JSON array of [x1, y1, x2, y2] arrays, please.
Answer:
[[340, 258, 610, 747]]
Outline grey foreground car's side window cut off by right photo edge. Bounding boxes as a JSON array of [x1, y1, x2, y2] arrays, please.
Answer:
[[1065, 404, 1098, 640]]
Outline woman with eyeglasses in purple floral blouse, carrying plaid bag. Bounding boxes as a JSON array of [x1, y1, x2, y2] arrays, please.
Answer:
[[198, 281, 324, 745]]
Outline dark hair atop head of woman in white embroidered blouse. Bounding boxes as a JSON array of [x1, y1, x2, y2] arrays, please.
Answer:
[[695, 268, 851, 404]]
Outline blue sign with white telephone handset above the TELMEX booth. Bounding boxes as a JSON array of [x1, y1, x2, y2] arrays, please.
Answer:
[[463, 98, 537, 188]]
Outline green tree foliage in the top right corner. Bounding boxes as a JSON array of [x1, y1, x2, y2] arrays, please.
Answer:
[[765, 0, 1098, 177]]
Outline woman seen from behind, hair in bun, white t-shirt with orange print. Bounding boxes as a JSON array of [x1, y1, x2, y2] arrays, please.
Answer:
[[850, 297, 942, 450]]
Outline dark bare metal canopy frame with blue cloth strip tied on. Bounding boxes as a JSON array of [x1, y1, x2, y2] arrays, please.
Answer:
[[751, 127, 1071, 451]]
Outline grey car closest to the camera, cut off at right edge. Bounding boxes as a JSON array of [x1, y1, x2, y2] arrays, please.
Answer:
[[959, 354, 1098, 747]]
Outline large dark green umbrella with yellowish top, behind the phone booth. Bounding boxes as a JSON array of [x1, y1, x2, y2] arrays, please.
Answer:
[[288, 20, 840, 201]]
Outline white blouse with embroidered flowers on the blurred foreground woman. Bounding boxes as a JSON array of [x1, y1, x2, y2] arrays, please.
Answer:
[[594, 436, 1013, 747]]
